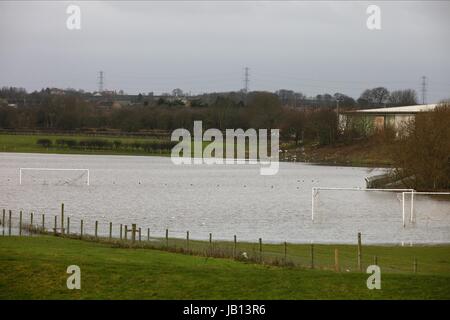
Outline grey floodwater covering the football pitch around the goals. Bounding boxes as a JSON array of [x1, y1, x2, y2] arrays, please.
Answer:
[[0, 153, 450, 245]]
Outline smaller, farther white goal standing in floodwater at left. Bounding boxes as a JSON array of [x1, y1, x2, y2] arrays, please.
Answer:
[[19, 168, 90, 186]]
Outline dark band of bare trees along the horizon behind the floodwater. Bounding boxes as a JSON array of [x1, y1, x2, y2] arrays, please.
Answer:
[[0, 88, 422, 145]]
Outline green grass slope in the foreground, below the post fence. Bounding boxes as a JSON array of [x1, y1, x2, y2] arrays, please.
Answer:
[[0, 236, 450, 299]]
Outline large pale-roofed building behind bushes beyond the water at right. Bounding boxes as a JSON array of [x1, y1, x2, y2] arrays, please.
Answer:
[[339, 104, 437, 134]]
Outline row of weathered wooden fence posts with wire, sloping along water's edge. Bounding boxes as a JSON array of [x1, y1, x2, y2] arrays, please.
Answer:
[[0, 204, 426, 272]]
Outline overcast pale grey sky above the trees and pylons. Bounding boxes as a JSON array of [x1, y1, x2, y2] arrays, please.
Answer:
[[0, 1, 450, 102]]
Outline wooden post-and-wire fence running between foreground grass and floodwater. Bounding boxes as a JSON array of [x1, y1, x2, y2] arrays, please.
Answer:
[[0, 205, 450, 273]]
